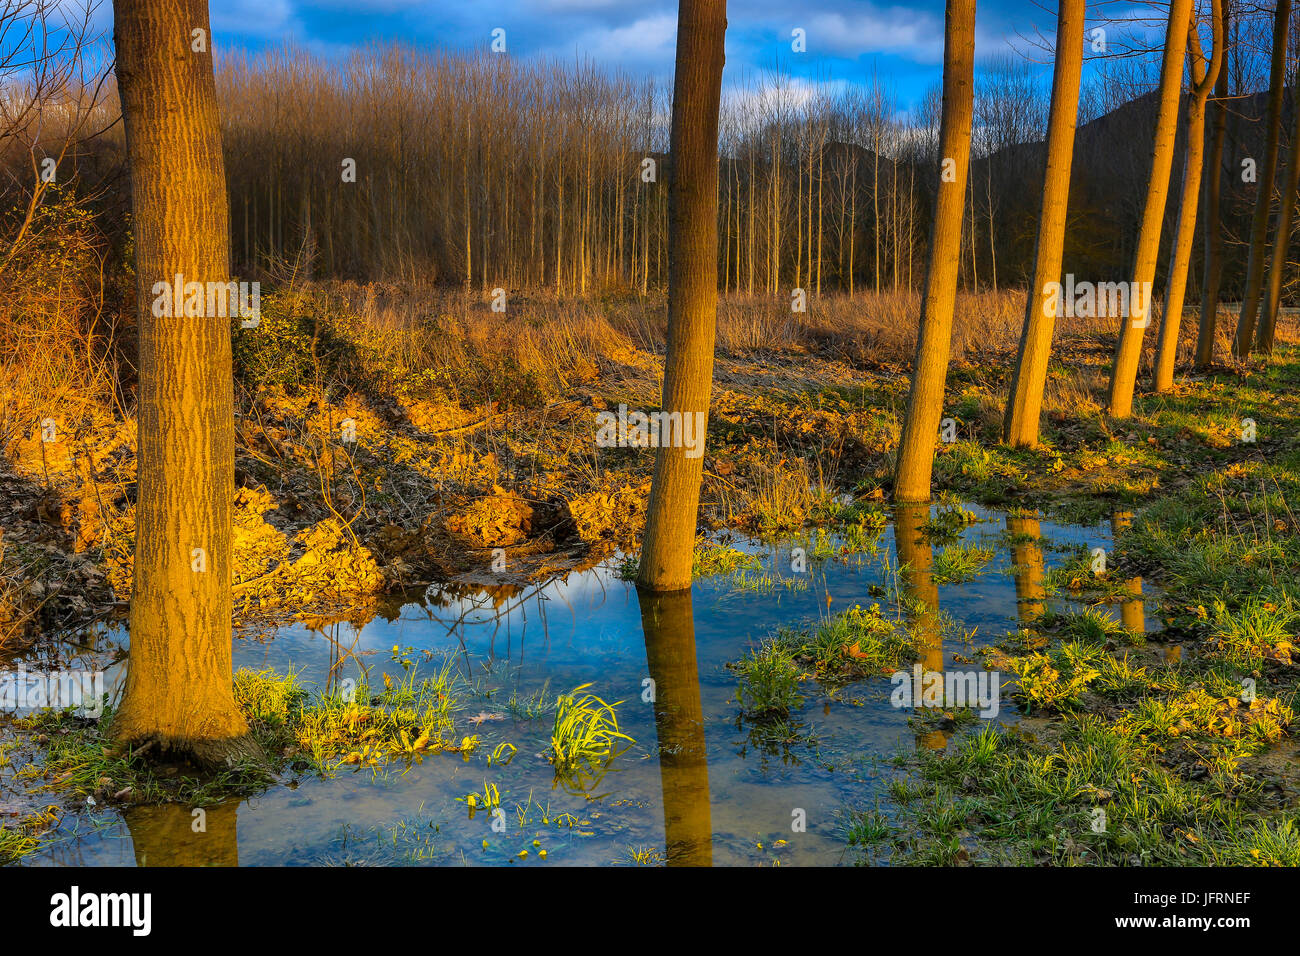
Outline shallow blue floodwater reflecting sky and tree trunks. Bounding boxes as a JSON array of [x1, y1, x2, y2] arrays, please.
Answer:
[[0, 506, 1157, 866]]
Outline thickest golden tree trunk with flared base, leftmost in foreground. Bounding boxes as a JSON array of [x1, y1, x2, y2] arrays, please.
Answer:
[[113, 0, 256, 765]]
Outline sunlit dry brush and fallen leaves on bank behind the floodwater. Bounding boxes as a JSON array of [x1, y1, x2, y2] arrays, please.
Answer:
[[0, 289, 1292, 644]]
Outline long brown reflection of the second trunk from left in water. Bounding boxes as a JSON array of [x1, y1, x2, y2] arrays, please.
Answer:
[[637, 591, 712, 866]]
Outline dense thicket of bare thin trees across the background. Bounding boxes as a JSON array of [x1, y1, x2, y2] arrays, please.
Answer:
[[9, 7, 1290, 321]]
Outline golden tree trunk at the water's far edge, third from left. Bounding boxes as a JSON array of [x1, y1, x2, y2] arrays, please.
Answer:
[[893, 0, 975, 502]]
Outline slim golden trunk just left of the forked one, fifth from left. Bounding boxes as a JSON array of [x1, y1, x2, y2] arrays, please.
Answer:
[[1106, 0, 1192, 419]]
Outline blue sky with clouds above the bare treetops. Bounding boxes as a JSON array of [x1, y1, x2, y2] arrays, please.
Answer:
[[195, 0, 1159, 109]]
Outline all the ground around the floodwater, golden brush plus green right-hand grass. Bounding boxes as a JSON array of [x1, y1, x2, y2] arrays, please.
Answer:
[[0, 287, 1300, 862]]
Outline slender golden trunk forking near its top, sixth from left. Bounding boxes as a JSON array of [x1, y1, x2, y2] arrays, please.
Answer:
[[1152, 0, 1223, 393]]
